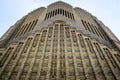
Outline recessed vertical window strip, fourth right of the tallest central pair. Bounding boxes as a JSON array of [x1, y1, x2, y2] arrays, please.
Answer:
[[85, 38, 105, 80]]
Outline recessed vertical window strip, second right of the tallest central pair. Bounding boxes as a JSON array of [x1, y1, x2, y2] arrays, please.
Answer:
[[72, 31, 85, 79]]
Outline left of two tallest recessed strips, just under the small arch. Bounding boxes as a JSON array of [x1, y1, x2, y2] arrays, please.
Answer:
[[50, 24, 59, 79]]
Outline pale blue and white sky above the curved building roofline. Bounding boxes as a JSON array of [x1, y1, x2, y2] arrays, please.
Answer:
[[0, 0, 120, 40]]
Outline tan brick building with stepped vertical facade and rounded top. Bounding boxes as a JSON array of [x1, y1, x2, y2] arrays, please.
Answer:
[[0, 1, 120, 80]]
